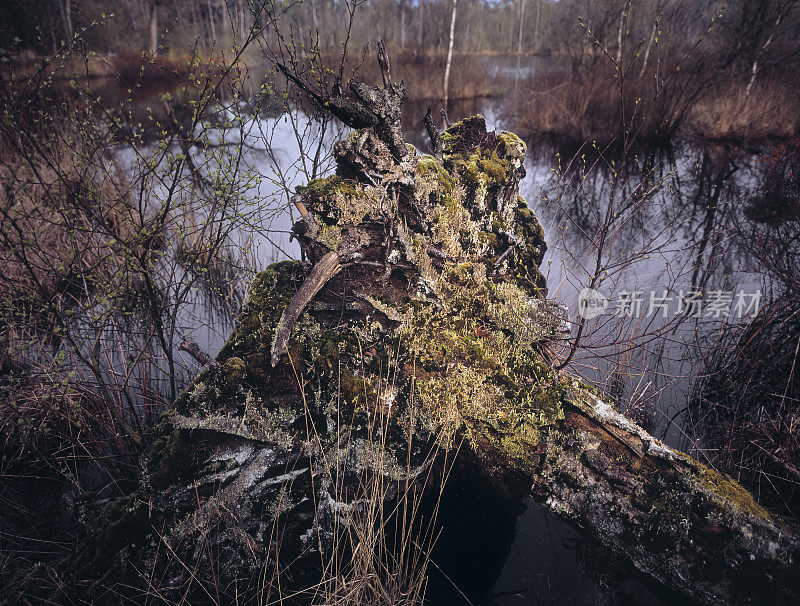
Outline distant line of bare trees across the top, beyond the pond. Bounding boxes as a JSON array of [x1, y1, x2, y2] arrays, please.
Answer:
[[0, 0, 800, 69]]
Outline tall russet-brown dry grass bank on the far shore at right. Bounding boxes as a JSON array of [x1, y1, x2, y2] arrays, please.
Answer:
[[510, 65, 800, 147]]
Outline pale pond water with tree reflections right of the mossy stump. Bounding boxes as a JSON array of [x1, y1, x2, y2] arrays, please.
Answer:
[[524, 139, 765, 456]]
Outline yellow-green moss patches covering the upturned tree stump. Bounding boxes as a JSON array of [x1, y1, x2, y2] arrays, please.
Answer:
[[170, 116, 563, 472]]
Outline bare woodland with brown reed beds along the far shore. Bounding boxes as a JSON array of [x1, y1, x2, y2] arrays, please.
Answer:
[[0, 0, 800, 143]]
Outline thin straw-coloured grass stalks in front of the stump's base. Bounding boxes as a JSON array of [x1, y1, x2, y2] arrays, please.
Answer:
[[296, 366, 452, 606]]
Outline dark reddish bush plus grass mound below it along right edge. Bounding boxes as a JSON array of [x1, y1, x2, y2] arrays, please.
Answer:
[[687, 140, 800, 516]]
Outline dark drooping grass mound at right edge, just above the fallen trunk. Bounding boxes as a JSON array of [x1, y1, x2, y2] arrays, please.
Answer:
[[687, 299, 800, 516]]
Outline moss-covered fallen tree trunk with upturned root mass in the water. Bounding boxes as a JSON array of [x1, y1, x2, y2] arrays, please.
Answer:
[[65, 53, 800, 604]]
